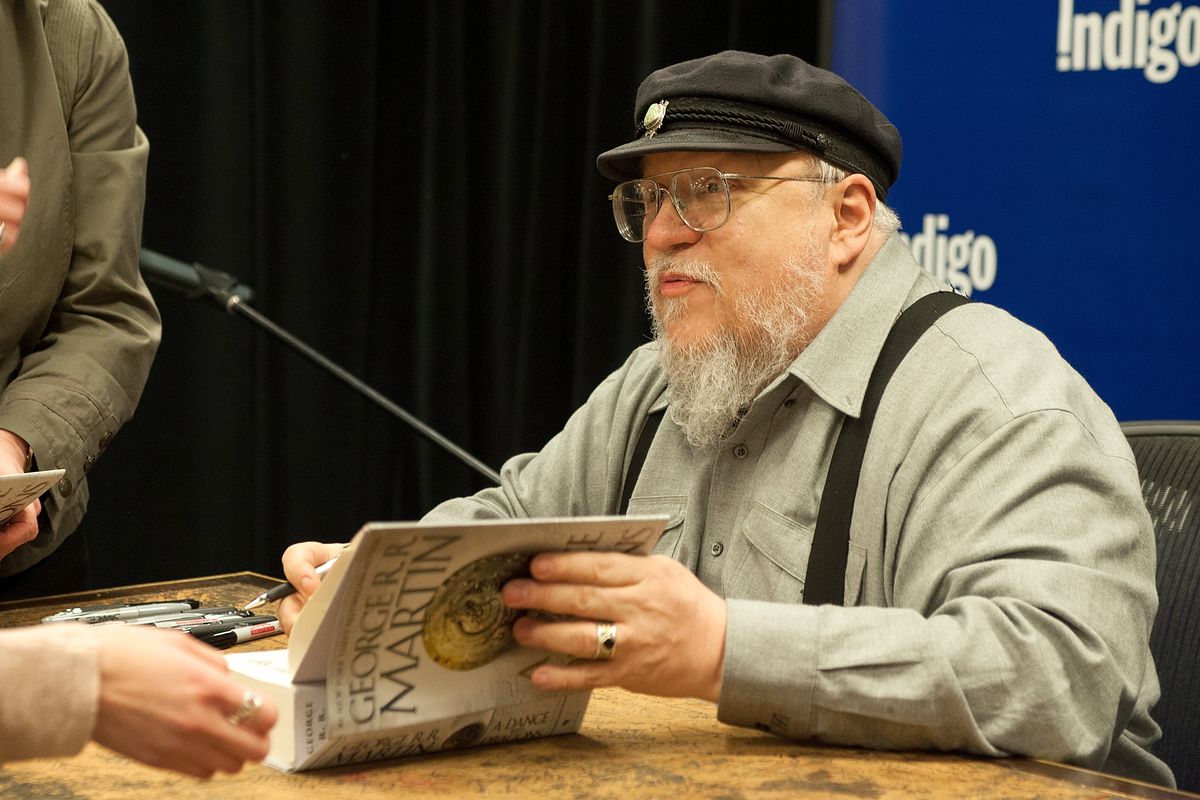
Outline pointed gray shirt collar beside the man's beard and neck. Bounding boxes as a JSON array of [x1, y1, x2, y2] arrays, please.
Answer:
[[788, 234, 925, 417]]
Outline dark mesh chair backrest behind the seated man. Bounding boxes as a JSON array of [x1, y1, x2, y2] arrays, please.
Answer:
[[1121, 421, 1200, 792]]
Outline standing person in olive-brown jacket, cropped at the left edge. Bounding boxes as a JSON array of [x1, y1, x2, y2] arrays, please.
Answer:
[[0, 0, 161, 600]]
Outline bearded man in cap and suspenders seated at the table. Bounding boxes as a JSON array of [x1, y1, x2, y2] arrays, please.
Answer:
[[281, 52, 1171, 784]]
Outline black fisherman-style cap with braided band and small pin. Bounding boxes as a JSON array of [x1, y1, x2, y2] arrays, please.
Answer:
[[596, 50, 901, 199]]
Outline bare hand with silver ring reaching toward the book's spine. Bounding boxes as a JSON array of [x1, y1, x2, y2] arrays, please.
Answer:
[[92, 625, 277, 777]]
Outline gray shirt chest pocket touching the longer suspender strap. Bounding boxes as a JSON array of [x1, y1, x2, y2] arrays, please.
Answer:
[[724, 503, 812, 603]]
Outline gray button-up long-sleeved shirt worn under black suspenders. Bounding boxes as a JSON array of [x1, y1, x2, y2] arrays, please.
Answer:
[[430, 237, 1171, 783]]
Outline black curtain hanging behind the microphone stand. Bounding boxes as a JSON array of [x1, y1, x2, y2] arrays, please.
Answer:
[[84, 0, 829, 585]]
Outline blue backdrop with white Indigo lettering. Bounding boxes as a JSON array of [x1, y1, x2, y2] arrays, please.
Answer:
[[833, 0, 1200, 420]]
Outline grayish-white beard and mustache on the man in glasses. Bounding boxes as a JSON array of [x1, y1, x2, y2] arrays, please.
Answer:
[[647, 241, 823, 449]]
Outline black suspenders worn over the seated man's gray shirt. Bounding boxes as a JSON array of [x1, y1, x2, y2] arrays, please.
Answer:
[[620, 291, 968, 606]]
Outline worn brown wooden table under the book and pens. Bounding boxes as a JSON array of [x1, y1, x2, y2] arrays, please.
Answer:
[[0, 572, 1200, 800]]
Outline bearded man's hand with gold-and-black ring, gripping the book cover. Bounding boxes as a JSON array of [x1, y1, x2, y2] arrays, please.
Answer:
[[500, 553, 726, 702]]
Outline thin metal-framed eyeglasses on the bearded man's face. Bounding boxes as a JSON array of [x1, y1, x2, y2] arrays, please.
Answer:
[[608, 167, 823, 242]]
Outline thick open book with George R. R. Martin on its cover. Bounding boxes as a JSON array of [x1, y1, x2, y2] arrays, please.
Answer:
[[226, 516, 666, 772]]
